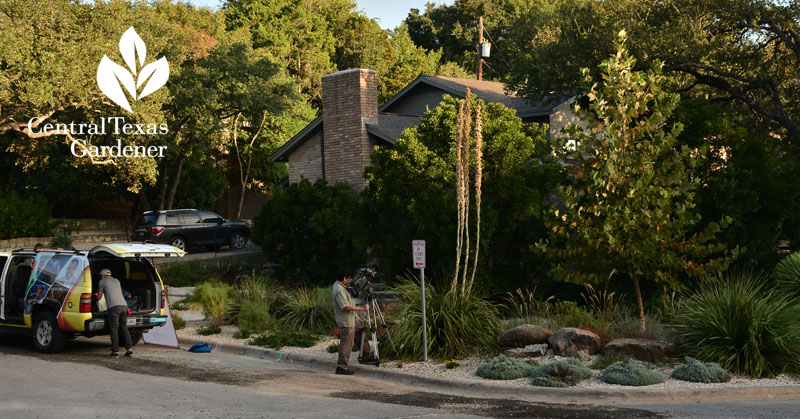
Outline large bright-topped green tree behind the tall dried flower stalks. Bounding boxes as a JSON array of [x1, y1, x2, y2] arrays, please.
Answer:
[[363, 96, 555, 290]]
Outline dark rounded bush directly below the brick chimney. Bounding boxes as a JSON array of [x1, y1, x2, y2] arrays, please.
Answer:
[[252, 179, 366, 284]]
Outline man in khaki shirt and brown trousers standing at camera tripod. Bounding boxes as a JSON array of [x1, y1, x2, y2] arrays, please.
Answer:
[[333, 269, 370, 375]]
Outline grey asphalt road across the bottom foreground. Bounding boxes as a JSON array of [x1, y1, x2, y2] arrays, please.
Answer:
[[0, 334, 800, 419]]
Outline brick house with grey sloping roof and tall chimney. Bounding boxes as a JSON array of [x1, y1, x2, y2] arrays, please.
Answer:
[[270, 69, 577, 189]]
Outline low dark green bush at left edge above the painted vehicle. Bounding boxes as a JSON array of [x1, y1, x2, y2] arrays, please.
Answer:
[[0, 191, 55, 240]]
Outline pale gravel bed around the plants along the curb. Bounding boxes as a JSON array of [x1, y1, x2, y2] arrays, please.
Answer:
[[170, 302, 800, 389]]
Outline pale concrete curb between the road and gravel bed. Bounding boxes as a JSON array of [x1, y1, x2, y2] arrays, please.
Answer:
[[173, 338, 800, 404]]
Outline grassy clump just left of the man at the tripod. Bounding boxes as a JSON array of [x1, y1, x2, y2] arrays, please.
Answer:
[[280, 286, 336, 334]]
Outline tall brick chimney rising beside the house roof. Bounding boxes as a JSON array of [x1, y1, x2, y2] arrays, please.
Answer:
[[322, 69, 378, 190]]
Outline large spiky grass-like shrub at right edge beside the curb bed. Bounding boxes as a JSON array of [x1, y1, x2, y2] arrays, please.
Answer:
[[677, 272, 800, 377]]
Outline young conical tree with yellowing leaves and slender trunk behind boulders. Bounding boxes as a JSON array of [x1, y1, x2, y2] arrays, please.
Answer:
[[540, 31, 735, 330]]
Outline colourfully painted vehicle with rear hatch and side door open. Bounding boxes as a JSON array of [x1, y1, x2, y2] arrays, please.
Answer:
[[0, 243, 185, 352]]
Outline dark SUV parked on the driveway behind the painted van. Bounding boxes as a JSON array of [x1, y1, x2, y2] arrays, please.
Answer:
[[133, 209, 250, 252]]
